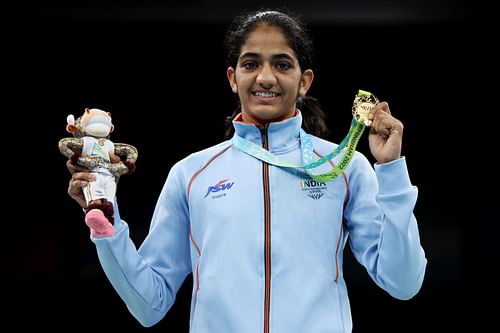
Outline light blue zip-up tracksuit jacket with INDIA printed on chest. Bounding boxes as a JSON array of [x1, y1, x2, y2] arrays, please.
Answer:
[[92, 113, 427, 333]]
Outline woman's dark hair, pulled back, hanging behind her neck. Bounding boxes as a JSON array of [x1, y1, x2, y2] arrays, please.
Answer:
[[224, 10, 329, 139]]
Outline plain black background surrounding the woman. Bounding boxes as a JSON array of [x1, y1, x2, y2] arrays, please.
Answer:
[[0, 0, 500, 332]]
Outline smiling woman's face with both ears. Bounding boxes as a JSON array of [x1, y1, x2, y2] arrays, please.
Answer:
[[227, 25, 314, 125]]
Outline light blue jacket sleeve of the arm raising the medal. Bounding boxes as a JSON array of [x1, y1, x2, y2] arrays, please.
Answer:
[[345, 156, 427, 300]]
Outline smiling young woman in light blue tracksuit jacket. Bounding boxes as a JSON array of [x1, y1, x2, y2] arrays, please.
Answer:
[[68, 11, 427, 333]]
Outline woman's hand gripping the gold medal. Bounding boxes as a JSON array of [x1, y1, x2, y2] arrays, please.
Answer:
[[368, 102, 403, 163]]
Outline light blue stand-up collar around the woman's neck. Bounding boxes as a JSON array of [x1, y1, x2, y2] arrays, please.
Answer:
[[233, 110, 302, 153]]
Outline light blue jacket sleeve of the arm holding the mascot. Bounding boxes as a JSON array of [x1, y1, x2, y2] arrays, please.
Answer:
[[92, 165, 191, 326]]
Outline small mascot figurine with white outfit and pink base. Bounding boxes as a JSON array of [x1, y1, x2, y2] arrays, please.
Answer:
[[59, 108, 137, 237]]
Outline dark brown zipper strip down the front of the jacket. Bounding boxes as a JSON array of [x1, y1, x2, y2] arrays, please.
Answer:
[[261, 125, 271, 333]]
